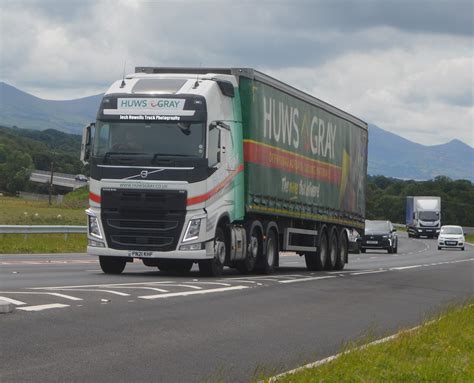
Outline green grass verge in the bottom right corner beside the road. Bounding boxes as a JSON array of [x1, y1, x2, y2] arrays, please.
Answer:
[[267, 301, 474, 383]]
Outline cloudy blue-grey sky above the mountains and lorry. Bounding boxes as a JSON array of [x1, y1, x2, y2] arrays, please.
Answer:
[[0, 0, 474, 146]]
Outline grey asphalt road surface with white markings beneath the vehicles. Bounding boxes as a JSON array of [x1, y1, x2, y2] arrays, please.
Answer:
[[0, 234, 474, 382]]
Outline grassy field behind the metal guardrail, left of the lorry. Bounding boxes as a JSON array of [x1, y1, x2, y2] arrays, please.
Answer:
[[0, 197, 87, 226]]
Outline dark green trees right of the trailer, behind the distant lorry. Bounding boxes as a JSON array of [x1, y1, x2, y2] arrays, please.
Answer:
[[366, 176, 474, 226]]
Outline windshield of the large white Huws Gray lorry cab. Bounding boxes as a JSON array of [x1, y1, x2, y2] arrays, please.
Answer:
[[92, 121, 205, 158]]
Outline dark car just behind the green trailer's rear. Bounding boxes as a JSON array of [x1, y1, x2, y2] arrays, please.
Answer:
[[359, 221, 398, 254]]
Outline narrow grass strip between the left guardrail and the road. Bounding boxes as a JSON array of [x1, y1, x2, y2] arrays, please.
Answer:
[[0, 234, 87, 254]]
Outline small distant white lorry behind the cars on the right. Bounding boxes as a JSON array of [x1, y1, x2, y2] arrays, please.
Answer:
[[405, 196, 441, 238]]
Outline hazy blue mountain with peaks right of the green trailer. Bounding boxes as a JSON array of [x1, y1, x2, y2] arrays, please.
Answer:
[[368, 124, 474, 181]]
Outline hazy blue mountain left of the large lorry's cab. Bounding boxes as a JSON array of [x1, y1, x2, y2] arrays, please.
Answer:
[[0, 82, 102, 134]]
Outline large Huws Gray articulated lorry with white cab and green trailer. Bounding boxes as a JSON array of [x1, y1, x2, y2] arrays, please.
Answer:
[[81, 67, 367, 276]]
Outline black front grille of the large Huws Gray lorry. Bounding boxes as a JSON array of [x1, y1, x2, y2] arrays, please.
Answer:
[[101, 189, 187, 251]]
